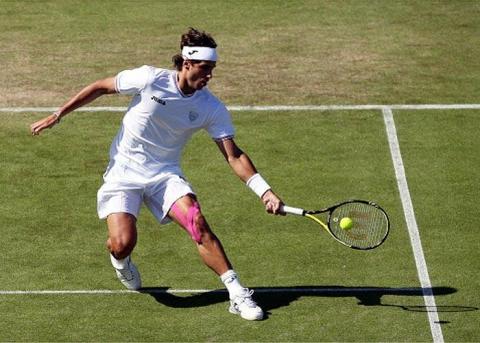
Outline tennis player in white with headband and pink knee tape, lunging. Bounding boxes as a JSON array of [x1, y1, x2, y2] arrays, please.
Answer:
[[31, 28, 282, 320]]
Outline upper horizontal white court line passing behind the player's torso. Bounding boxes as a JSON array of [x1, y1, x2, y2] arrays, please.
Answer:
[[0, 104, 480, 113]]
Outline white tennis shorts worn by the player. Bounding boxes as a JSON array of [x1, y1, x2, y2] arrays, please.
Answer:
[[97, 163, 195, 224]]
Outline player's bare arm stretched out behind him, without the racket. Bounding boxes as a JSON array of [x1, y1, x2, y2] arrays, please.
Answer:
[[30, 77, 116, 135]]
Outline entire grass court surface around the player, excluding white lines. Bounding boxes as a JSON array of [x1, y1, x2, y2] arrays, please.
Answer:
[[0, 1, 480, 342]]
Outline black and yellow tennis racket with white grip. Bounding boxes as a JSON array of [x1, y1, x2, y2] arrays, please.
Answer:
[[281, 200, 390, 250]]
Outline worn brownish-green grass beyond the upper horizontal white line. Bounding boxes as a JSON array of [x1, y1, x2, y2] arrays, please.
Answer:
[[0, 0, 480, 107]]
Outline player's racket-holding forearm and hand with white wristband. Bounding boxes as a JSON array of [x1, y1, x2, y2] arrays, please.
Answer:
[[217, 138, 284, 215]]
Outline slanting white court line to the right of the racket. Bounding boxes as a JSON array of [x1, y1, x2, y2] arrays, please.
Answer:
[[382, 108, 443, 342]]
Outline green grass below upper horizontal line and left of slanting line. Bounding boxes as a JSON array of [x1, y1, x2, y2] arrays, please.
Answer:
[[0, 112, 429, 341]]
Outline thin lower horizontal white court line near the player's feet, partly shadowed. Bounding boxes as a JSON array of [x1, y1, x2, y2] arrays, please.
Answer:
[[0, 287, 423, 295]]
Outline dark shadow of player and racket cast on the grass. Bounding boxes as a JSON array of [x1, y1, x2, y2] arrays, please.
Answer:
[[140, 286, 478, 320]]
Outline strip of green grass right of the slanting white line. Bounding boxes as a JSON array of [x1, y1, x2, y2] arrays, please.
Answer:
[[397, 111, 480, 341]]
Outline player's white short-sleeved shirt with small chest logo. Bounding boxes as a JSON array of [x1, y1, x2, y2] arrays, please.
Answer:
[[110, 66, 235, 177]]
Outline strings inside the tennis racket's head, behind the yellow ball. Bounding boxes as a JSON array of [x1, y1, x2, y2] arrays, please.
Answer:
[[329, 202, 389, 249]]
